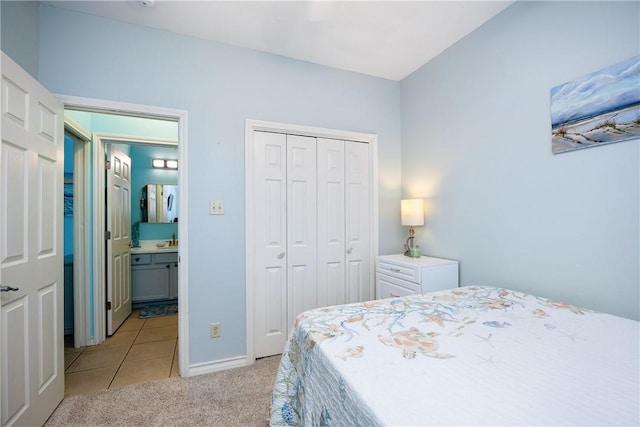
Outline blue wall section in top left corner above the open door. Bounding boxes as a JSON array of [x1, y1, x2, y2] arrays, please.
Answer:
[[0, 0, 39, 79]]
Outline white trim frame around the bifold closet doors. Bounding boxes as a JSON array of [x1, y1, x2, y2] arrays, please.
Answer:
[[244, 119, 378, 363]]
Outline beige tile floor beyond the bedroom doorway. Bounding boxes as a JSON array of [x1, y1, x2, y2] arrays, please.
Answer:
[[64, 309, 178, 396]]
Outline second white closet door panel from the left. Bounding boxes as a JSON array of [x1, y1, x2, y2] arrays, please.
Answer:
[[286, 135, 318, 325]]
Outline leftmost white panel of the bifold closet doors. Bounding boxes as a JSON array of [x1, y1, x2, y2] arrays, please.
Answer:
[[248, 132, 290, 357]]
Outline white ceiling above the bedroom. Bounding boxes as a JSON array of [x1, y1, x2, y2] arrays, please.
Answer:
[[43, 0, 513, 80]]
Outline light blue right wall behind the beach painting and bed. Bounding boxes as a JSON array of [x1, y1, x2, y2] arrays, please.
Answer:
[[401, 2, 640, 319]]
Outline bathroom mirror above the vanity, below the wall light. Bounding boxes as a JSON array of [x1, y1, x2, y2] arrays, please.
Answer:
[[140, 184, 178, 223]]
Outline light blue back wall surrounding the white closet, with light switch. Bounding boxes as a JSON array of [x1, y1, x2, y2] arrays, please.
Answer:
[[39, 6, 403, 364]]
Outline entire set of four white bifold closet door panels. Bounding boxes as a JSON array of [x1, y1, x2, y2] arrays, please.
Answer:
[[249, 131, 373, 357]]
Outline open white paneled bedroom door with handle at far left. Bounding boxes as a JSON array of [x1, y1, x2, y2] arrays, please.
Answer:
[[0, 53, 64, 426]]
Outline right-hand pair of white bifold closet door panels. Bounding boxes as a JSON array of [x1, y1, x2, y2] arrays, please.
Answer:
[[317, 139, 373, 306]]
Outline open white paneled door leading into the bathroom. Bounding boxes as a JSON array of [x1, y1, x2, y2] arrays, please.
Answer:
[[105, 144, 131, 335]]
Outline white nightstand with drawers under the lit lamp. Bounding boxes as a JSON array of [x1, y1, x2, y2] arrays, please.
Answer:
[[376, 255, 458, 299]]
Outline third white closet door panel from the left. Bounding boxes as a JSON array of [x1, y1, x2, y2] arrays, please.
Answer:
[[318, 139, 346, 306]]
